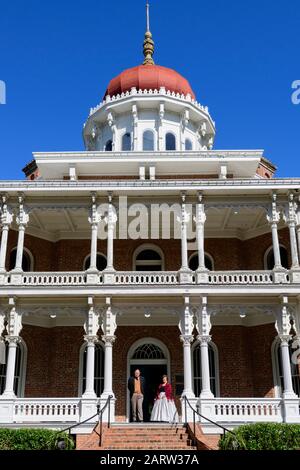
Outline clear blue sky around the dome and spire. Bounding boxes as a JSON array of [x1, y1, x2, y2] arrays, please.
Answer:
[[0, 0, 300, 179]]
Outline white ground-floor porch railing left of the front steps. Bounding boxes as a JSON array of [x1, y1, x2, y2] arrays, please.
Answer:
[[13, 398, 80, 423]]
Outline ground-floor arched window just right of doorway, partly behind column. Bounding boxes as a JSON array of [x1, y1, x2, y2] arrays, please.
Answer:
[[192, 341, 219, 397]]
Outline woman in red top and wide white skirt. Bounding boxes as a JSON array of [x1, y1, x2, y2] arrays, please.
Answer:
[[150, 375, 178, 423]]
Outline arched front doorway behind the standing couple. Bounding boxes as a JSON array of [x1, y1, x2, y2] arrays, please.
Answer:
[[126, 338, 170, 421]]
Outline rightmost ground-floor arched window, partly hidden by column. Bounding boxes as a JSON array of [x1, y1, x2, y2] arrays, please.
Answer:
[[272, 338, 300, 396]]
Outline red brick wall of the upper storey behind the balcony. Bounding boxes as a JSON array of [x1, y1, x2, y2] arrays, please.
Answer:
[[6, 229, 289, 271]]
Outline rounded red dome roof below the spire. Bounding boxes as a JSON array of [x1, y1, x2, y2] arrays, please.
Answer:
[[105, 65, 195, 99]]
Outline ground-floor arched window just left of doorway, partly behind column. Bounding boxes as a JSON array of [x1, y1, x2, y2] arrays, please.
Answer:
[[79, 342, 104, 397]]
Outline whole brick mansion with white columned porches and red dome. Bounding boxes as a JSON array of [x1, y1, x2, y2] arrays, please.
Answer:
[[0, 6, 300, 444]]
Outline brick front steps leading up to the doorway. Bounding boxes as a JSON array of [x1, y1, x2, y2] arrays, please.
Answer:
[[76, 423, 197, 450]]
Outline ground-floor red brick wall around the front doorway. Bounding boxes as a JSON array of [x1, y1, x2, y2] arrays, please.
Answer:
[[22, 324, 276, 420]]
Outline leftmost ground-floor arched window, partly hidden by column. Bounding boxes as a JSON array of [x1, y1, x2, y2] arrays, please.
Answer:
[[0, 340, 27, 397]]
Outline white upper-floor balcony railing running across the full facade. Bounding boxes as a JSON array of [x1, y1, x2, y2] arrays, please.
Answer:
[[0, 270, 292, 287]]
